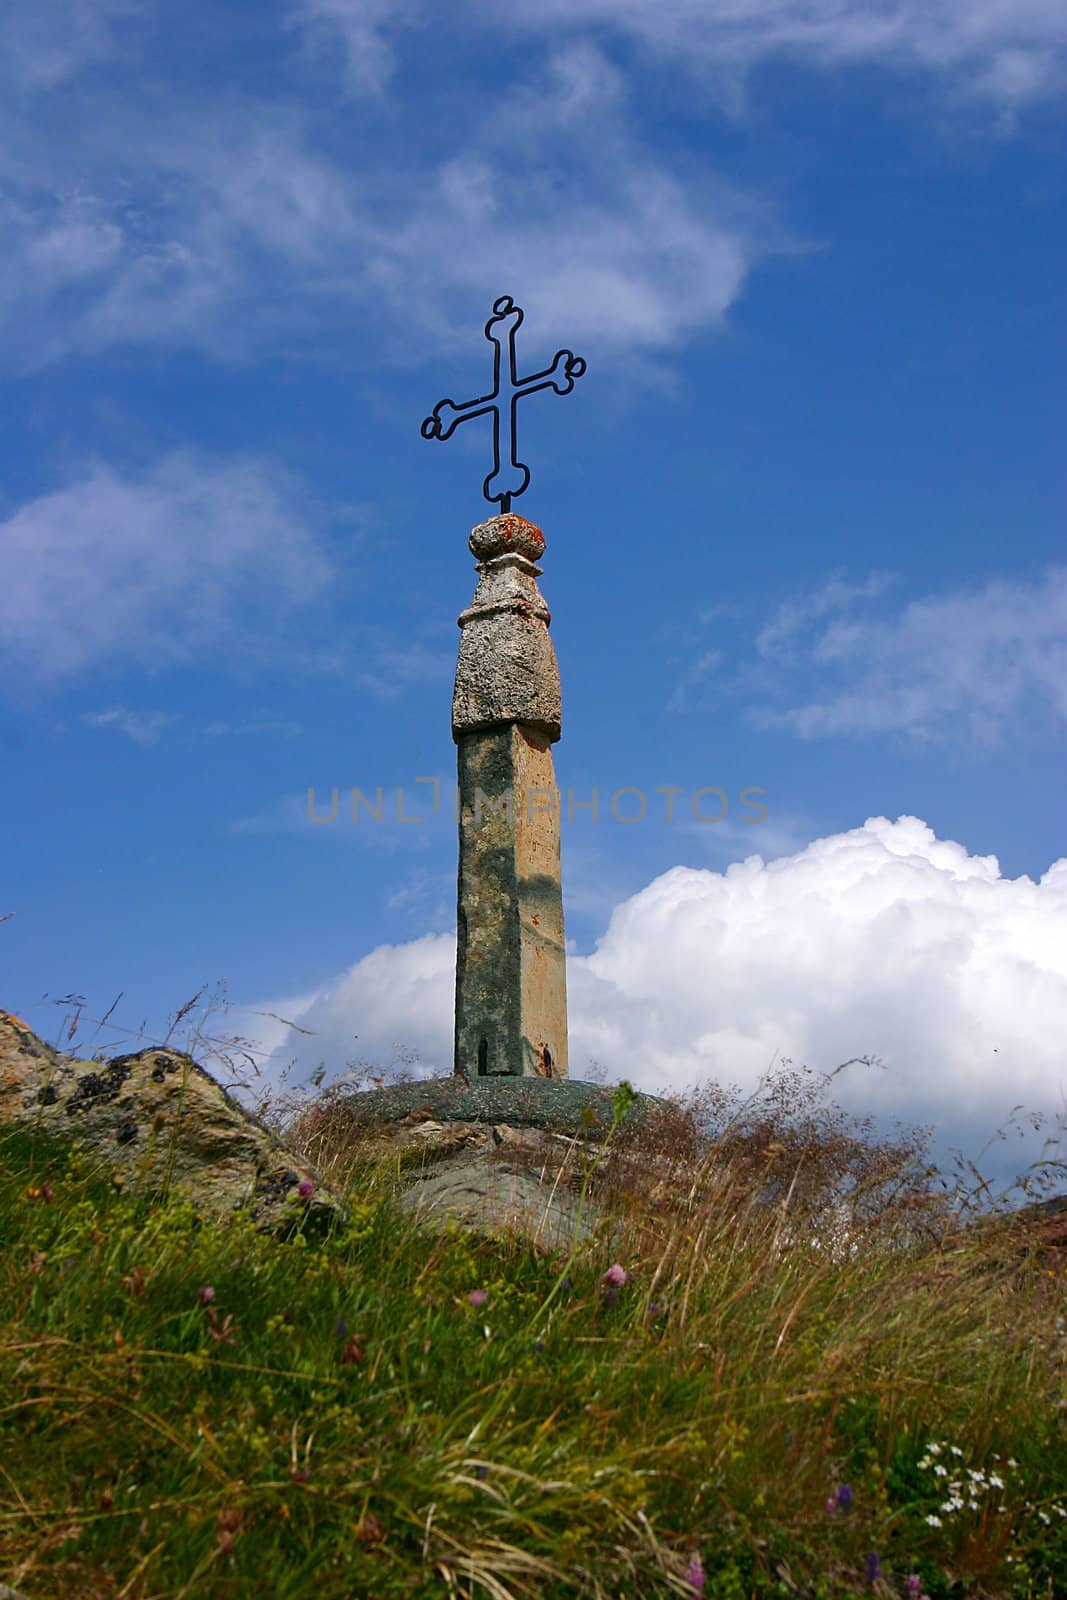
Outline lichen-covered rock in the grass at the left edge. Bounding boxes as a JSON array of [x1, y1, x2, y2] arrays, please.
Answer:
[[0, 1011, 346, 1232]]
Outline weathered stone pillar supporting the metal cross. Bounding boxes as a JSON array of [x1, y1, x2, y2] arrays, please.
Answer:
[[453, 512, 568, 1082]]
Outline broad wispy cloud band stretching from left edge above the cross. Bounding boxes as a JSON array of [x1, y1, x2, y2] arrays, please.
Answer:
[[0, 23, 792, 370]]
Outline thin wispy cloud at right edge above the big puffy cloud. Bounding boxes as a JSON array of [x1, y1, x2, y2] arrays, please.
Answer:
[[750, 566, 1067, 749]]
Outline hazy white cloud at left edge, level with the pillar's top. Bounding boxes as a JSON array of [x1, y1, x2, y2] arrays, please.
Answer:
[[0, 451, 331, 686]]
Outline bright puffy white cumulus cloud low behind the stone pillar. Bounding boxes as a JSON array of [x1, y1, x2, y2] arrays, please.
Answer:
[[225, 816, 1067, 1187]]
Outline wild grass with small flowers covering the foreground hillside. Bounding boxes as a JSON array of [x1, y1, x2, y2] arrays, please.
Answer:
[[0, 1011, 1067, 1600]]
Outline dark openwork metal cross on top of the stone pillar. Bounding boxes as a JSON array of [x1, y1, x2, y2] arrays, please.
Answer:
[[422, 294, 585, 512]]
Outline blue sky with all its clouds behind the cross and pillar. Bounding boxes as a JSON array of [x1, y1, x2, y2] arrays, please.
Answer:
[[0, 0, 1067, 1216]]
